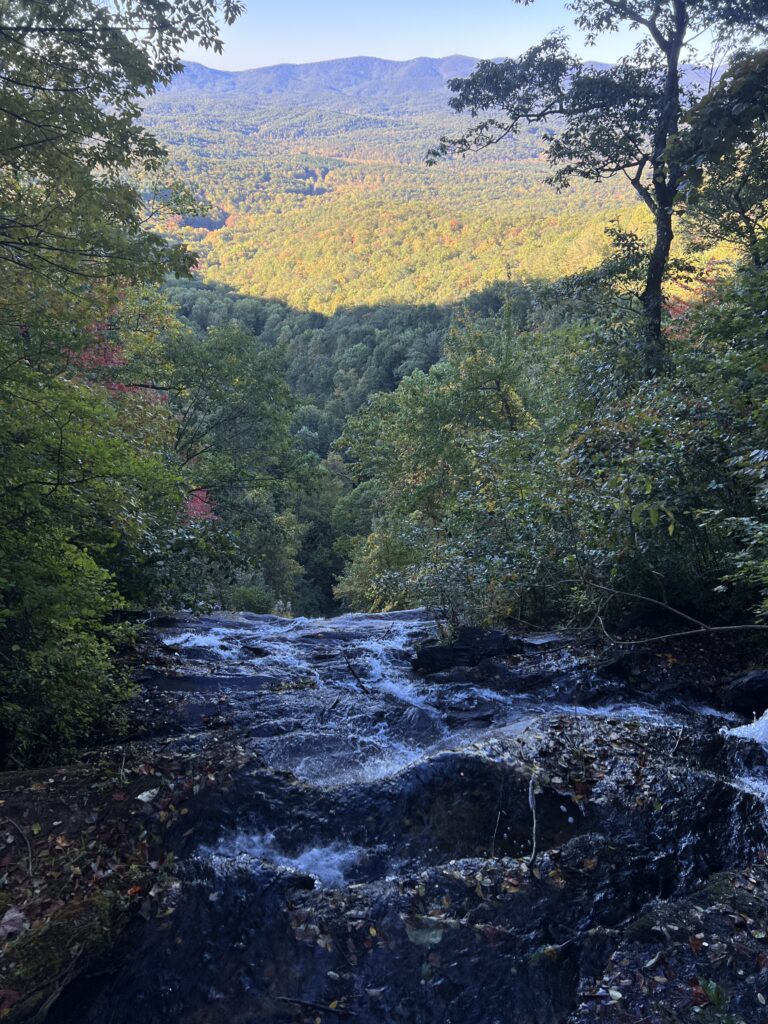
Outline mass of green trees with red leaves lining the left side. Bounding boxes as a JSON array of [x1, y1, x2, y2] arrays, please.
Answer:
[[0, 0, 307, 764]]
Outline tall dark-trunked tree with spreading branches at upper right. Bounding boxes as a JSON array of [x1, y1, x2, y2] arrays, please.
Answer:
[[429, 0, 768, 375]]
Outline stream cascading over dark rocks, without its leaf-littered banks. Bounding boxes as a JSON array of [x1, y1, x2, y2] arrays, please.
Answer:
[[53, 611, 768, 1024]]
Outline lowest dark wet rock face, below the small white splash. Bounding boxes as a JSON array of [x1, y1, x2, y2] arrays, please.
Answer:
[[46, 764, 759, 1024]]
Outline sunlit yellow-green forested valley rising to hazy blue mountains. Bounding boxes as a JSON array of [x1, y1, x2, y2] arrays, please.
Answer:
[[144, 57, 644, 312]]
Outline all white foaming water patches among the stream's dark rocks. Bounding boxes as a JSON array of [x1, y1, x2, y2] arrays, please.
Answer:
[[150, 610, 768, 887]]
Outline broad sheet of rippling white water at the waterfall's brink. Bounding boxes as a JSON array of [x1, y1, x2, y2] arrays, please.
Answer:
[[156, 612, 445, 783]]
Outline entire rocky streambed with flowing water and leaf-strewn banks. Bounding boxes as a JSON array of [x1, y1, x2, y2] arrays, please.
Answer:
[[0, 612, 768, 1024]]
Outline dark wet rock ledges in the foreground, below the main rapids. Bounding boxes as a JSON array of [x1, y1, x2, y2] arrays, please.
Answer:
[[45, 717, 763, 1024]]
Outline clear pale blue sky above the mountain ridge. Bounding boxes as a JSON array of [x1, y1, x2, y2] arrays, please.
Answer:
[[184, 0, 636, 69]]
